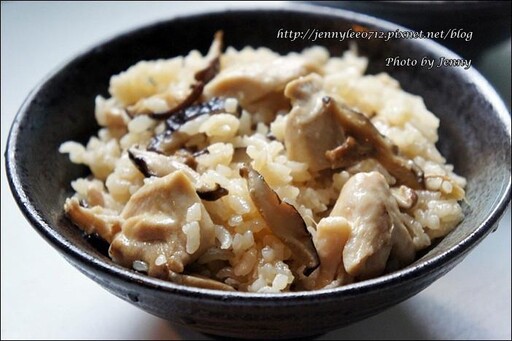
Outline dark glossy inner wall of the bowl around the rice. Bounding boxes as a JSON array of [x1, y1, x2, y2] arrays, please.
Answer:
[[6, 6, 510, 338]]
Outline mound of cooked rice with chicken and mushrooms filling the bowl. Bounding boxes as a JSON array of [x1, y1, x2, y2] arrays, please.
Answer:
[[60, 32, 465, 292]]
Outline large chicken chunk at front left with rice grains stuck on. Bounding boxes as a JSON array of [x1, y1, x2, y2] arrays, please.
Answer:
[[109, 170, 215, 279]]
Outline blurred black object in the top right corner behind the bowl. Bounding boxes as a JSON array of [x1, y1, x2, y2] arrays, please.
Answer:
[[315, 1, 511, 59]]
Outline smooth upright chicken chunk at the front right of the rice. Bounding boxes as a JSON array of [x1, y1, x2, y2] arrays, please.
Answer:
[[330, 172, 415, 279]]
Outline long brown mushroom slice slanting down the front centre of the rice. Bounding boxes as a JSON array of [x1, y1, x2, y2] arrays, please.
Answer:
[[240, 165, 320, 275]]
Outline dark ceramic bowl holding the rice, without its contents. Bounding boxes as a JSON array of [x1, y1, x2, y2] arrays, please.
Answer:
[[6, 8, 510, 338]]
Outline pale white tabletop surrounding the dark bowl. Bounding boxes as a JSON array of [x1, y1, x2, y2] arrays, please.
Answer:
[[1, 2, 511, 339]]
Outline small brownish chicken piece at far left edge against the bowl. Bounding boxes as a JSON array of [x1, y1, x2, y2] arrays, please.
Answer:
[[64, 198, 122, 243]]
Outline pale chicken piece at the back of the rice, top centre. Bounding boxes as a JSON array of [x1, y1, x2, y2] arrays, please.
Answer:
[[204, 56, 315, 124]]
